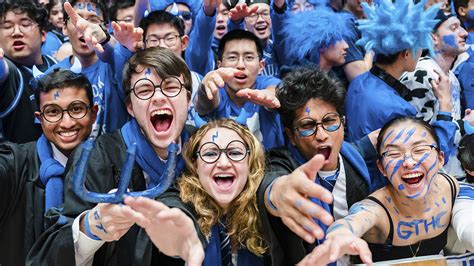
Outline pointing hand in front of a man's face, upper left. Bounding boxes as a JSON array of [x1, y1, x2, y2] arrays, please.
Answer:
[[64, 2, 107, 53]]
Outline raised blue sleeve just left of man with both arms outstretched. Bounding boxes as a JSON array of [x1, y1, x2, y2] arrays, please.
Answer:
[[184, 8, 216, 76]]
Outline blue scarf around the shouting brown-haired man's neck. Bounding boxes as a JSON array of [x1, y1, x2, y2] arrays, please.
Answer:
[[121, 118, 188, 187]]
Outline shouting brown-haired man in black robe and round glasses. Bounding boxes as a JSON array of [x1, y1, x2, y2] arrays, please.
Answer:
[[28, 47, 199, 265]]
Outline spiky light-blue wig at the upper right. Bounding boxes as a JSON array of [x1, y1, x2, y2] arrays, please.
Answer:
[[357, 0, 440, 56]]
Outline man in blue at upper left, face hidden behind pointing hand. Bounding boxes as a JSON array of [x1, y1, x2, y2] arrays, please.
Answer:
[[51, 1, 133, 136]]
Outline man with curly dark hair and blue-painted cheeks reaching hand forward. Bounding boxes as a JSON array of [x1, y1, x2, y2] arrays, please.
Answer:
[[258, 68, 376, 265]]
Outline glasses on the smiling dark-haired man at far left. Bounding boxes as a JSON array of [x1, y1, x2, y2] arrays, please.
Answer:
[[41, 101, 91, 123]]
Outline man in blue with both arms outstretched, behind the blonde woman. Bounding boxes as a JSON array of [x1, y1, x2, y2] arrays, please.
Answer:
[[194, 30, 283, 149]]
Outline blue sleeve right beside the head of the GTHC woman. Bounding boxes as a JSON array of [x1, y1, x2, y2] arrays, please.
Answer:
[[431, 120, 457, 164]]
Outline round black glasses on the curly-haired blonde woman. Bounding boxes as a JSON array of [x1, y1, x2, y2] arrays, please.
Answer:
[[196, 140, 250, 163]]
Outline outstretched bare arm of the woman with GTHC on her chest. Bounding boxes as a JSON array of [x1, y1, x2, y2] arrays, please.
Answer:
[[301, 200, 383, 265]]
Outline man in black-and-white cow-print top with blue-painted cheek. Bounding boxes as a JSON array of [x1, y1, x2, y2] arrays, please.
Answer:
[[400, 9, 472, 177]]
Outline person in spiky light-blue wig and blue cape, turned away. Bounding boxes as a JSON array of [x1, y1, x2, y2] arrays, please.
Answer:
[[345, 0, 456, 188]]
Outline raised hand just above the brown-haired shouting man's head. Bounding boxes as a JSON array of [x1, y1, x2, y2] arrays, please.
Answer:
[[112, 21, 145, 53]]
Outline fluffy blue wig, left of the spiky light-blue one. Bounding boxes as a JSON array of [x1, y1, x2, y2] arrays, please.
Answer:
[[282, 6, 355, 64]]
